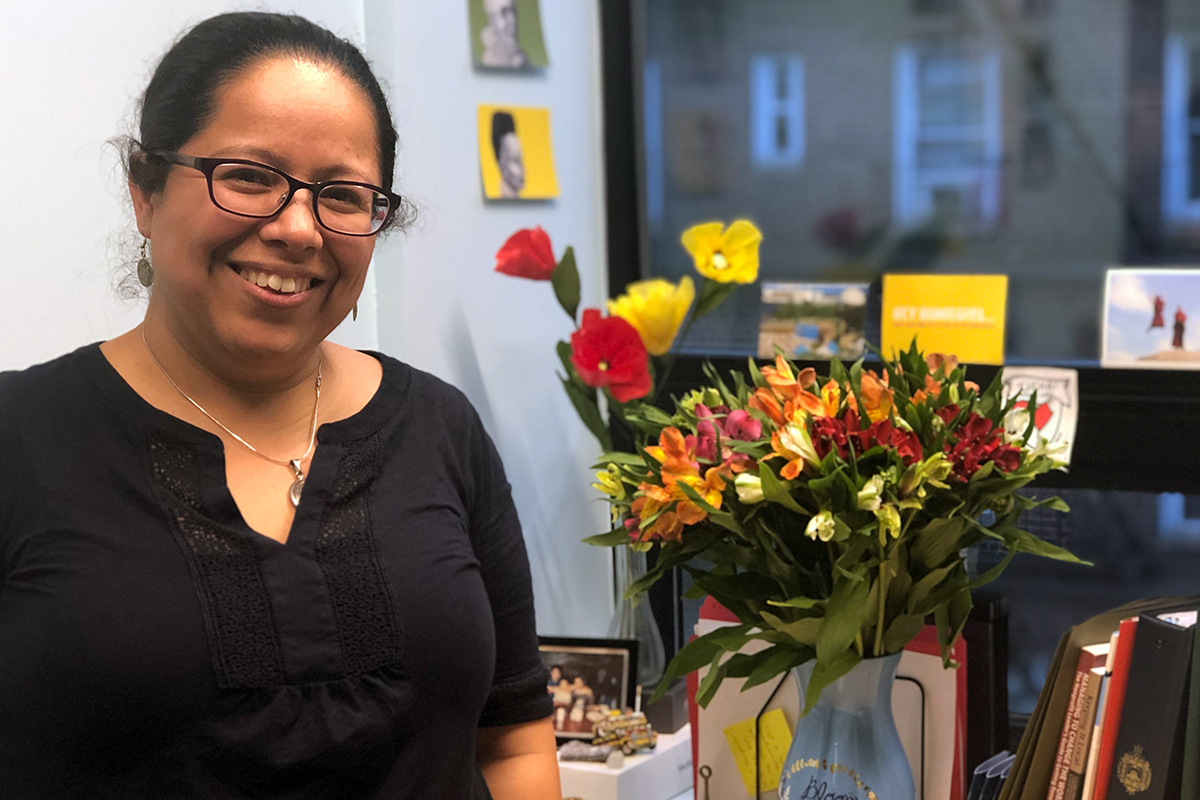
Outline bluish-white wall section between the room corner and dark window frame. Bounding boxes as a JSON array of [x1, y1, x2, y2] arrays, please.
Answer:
[[365, 0, 611, 636]]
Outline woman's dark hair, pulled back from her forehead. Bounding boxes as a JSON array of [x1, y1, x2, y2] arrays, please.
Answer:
[[125, 12, 410, 227]]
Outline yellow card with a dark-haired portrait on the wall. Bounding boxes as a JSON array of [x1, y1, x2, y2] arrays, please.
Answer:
[[479, 106, 558, 200]]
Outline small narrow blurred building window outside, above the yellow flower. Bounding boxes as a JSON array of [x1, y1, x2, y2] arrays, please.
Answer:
[[750, 55, 804, 169]]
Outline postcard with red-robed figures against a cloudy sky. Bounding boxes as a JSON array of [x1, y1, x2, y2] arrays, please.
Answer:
[[1100, 267, 1200, 369]]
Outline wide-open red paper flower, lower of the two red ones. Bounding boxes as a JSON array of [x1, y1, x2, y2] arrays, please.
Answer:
[[571, 308, 653, 403]]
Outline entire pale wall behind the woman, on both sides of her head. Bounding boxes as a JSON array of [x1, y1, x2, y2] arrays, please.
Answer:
[[0, 0, 611, 636]]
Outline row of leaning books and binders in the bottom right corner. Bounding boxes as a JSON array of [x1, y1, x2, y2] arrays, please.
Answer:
[[1000, 596, 1200, 800]]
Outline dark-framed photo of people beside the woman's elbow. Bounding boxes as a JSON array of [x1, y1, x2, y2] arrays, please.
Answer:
[[539, 636, 637, 739]]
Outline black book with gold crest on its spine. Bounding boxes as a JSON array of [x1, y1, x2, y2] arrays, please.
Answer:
[[1108, 613, 1192, 800]]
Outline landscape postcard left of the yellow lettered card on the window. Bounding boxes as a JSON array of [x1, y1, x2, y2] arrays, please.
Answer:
[[758, 283, 868, 361]]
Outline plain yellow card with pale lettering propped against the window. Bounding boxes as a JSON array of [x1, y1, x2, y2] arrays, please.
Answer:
[[880, 275, 1008, 365]]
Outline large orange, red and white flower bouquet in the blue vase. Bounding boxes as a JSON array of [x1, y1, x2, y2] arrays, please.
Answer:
[[587, 343, 1078, 712]]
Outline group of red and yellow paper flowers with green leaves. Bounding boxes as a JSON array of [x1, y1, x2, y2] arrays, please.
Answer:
[[496, 219, 762, 452]]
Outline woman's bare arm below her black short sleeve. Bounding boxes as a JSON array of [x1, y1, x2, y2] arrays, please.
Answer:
[[475, 717, 563, 800]]
